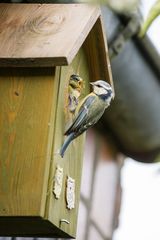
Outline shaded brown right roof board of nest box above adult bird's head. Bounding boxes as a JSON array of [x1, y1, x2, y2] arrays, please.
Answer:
[[84, 17, 114, 94]]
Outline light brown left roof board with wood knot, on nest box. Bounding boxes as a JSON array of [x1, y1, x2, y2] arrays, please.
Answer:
[[0, 4, 100, 66]]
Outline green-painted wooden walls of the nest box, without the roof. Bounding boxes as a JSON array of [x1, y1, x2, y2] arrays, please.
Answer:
[[0, 48, 89, 238]]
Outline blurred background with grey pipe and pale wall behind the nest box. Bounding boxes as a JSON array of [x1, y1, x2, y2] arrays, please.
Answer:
[[1, 0, 160, 240]]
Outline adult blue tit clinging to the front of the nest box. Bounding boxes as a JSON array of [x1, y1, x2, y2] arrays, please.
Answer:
[[60, 80, 113, 158]]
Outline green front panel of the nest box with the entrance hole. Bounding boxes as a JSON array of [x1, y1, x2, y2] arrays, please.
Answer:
[[46, 48, 89, 237]]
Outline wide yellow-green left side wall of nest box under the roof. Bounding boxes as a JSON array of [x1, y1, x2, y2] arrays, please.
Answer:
[[0, 68, 56, 218]]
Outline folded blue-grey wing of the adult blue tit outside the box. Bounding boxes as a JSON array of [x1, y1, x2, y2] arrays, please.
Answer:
[[65, 95, 96, 135]]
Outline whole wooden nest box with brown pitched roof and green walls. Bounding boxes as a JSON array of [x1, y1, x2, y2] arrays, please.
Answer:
[[0, 4, 112, 238]]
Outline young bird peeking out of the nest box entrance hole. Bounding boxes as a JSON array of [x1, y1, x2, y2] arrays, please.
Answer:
[[68, 74, 83, 113]]
